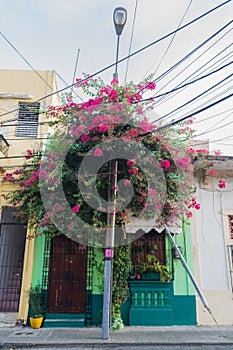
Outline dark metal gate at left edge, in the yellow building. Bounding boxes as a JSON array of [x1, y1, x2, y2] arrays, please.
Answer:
[[0, 206, 26, 312]]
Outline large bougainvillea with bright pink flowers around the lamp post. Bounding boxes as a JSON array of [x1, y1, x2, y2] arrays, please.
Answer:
[[5, 74, 224, 328]]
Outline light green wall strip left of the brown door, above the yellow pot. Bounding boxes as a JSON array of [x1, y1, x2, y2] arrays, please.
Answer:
[[32, 235, 45, 285]]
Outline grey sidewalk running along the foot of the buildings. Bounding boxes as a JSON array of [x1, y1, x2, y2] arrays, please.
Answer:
[[0, 326, 233, 349]]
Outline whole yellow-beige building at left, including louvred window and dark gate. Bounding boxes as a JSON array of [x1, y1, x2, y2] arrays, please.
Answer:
[[0, 70, 60, 326]]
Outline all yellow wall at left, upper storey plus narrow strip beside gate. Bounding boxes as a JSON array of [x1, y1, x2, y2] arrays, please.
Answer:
[[0, 70, 60, 321]]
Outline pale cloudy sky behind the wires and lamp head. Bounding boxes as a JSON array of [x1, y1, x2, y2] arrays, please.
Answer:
[[0, 0, 233, 155]]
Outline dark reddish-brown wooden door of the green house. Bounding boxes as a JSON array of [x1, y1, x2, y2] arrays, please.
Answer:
[[47, 235, 87, 314]]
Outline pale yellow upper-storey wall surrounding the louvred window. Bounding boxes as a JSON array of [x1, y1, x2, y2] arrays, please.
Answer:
[[0, 70, 59, 172]]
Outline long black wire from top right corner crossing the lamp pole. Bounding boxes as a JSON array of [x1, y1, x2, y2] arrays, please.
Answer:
[[0, 0, 232, 121]]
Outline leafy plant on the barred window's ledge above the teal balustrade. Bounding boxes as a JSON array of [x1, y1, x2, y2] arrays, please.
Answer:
[[139, 254, 171, 282]]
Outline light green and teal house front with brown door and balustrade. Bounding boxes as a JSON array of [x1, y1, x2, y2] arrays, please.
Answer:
[[29, 225, 196, 327]]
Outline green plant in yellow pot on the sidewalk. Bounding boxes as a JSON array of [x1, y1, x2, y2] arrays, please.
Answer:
[[27, 284, 43, 328]]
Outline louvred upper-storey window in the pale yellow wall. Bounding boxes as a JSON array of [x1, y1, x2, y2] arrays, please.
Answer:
[[16, 102, 40, 138]]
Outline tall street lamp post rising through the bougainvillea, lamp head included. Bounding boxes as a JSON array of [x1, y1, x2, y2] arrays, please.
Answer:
[[102, 7, 127, 340]]
